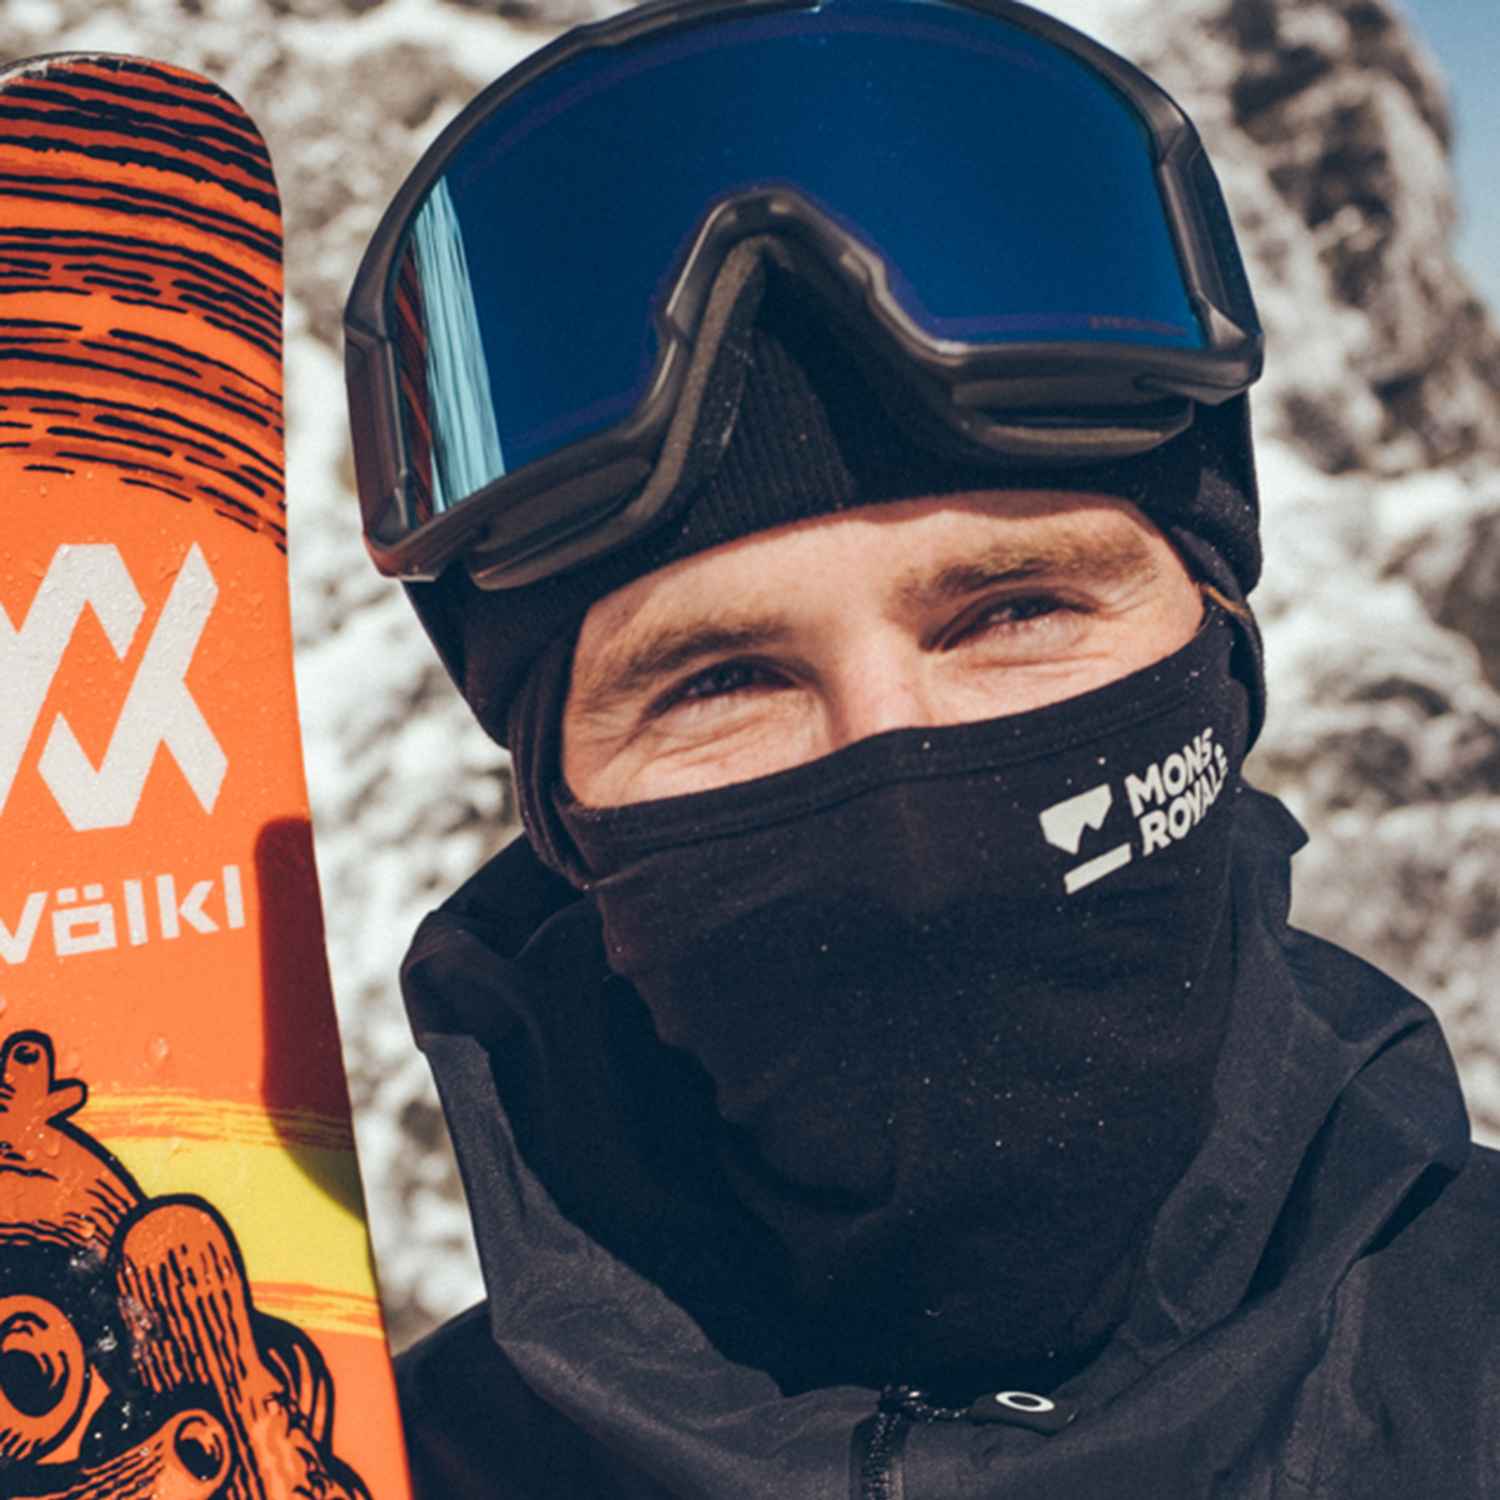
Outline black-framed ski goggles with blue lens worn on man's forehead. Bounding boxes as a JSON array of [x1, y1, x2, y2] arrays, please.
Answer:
[[345, 0, 1262, 588]]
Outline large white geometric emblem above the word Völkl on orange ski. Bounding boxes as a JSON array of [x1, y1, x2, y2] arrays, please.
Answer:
[[0, 543, 230, 831]]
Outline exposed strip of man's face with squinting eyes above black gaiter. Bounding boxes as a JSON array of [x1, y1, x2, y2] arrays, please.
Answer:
[[563, 491, 1202, 807]]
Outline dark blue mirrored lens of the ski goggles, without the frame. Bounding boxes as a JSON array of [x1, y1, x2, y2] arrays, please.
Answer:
[[392, 0, 1206, 513]]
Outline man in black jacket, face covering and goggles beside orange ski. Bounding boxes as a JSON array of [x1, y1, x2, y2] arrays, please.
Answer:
[[348, 0, 1500, 1500]]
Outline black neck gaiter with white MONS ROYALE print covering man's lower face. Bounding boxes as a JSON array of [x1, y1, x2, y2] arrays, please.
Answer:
[[558, 611, 1248, 1398]]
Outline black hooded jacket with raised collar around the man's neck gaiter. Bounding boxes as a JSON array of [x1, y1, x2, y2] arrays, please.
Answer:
[[398, 794, 1500, 1500]]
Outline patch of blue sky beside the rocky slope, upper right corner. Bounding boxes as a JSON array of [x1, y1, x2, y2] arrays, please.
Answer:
[[1398, 0, 1500, 314]]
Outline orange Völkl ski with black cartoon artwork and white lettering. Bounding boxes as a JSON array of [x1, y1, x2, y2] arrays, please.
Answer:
[[0, 54, 408, 1500]]
